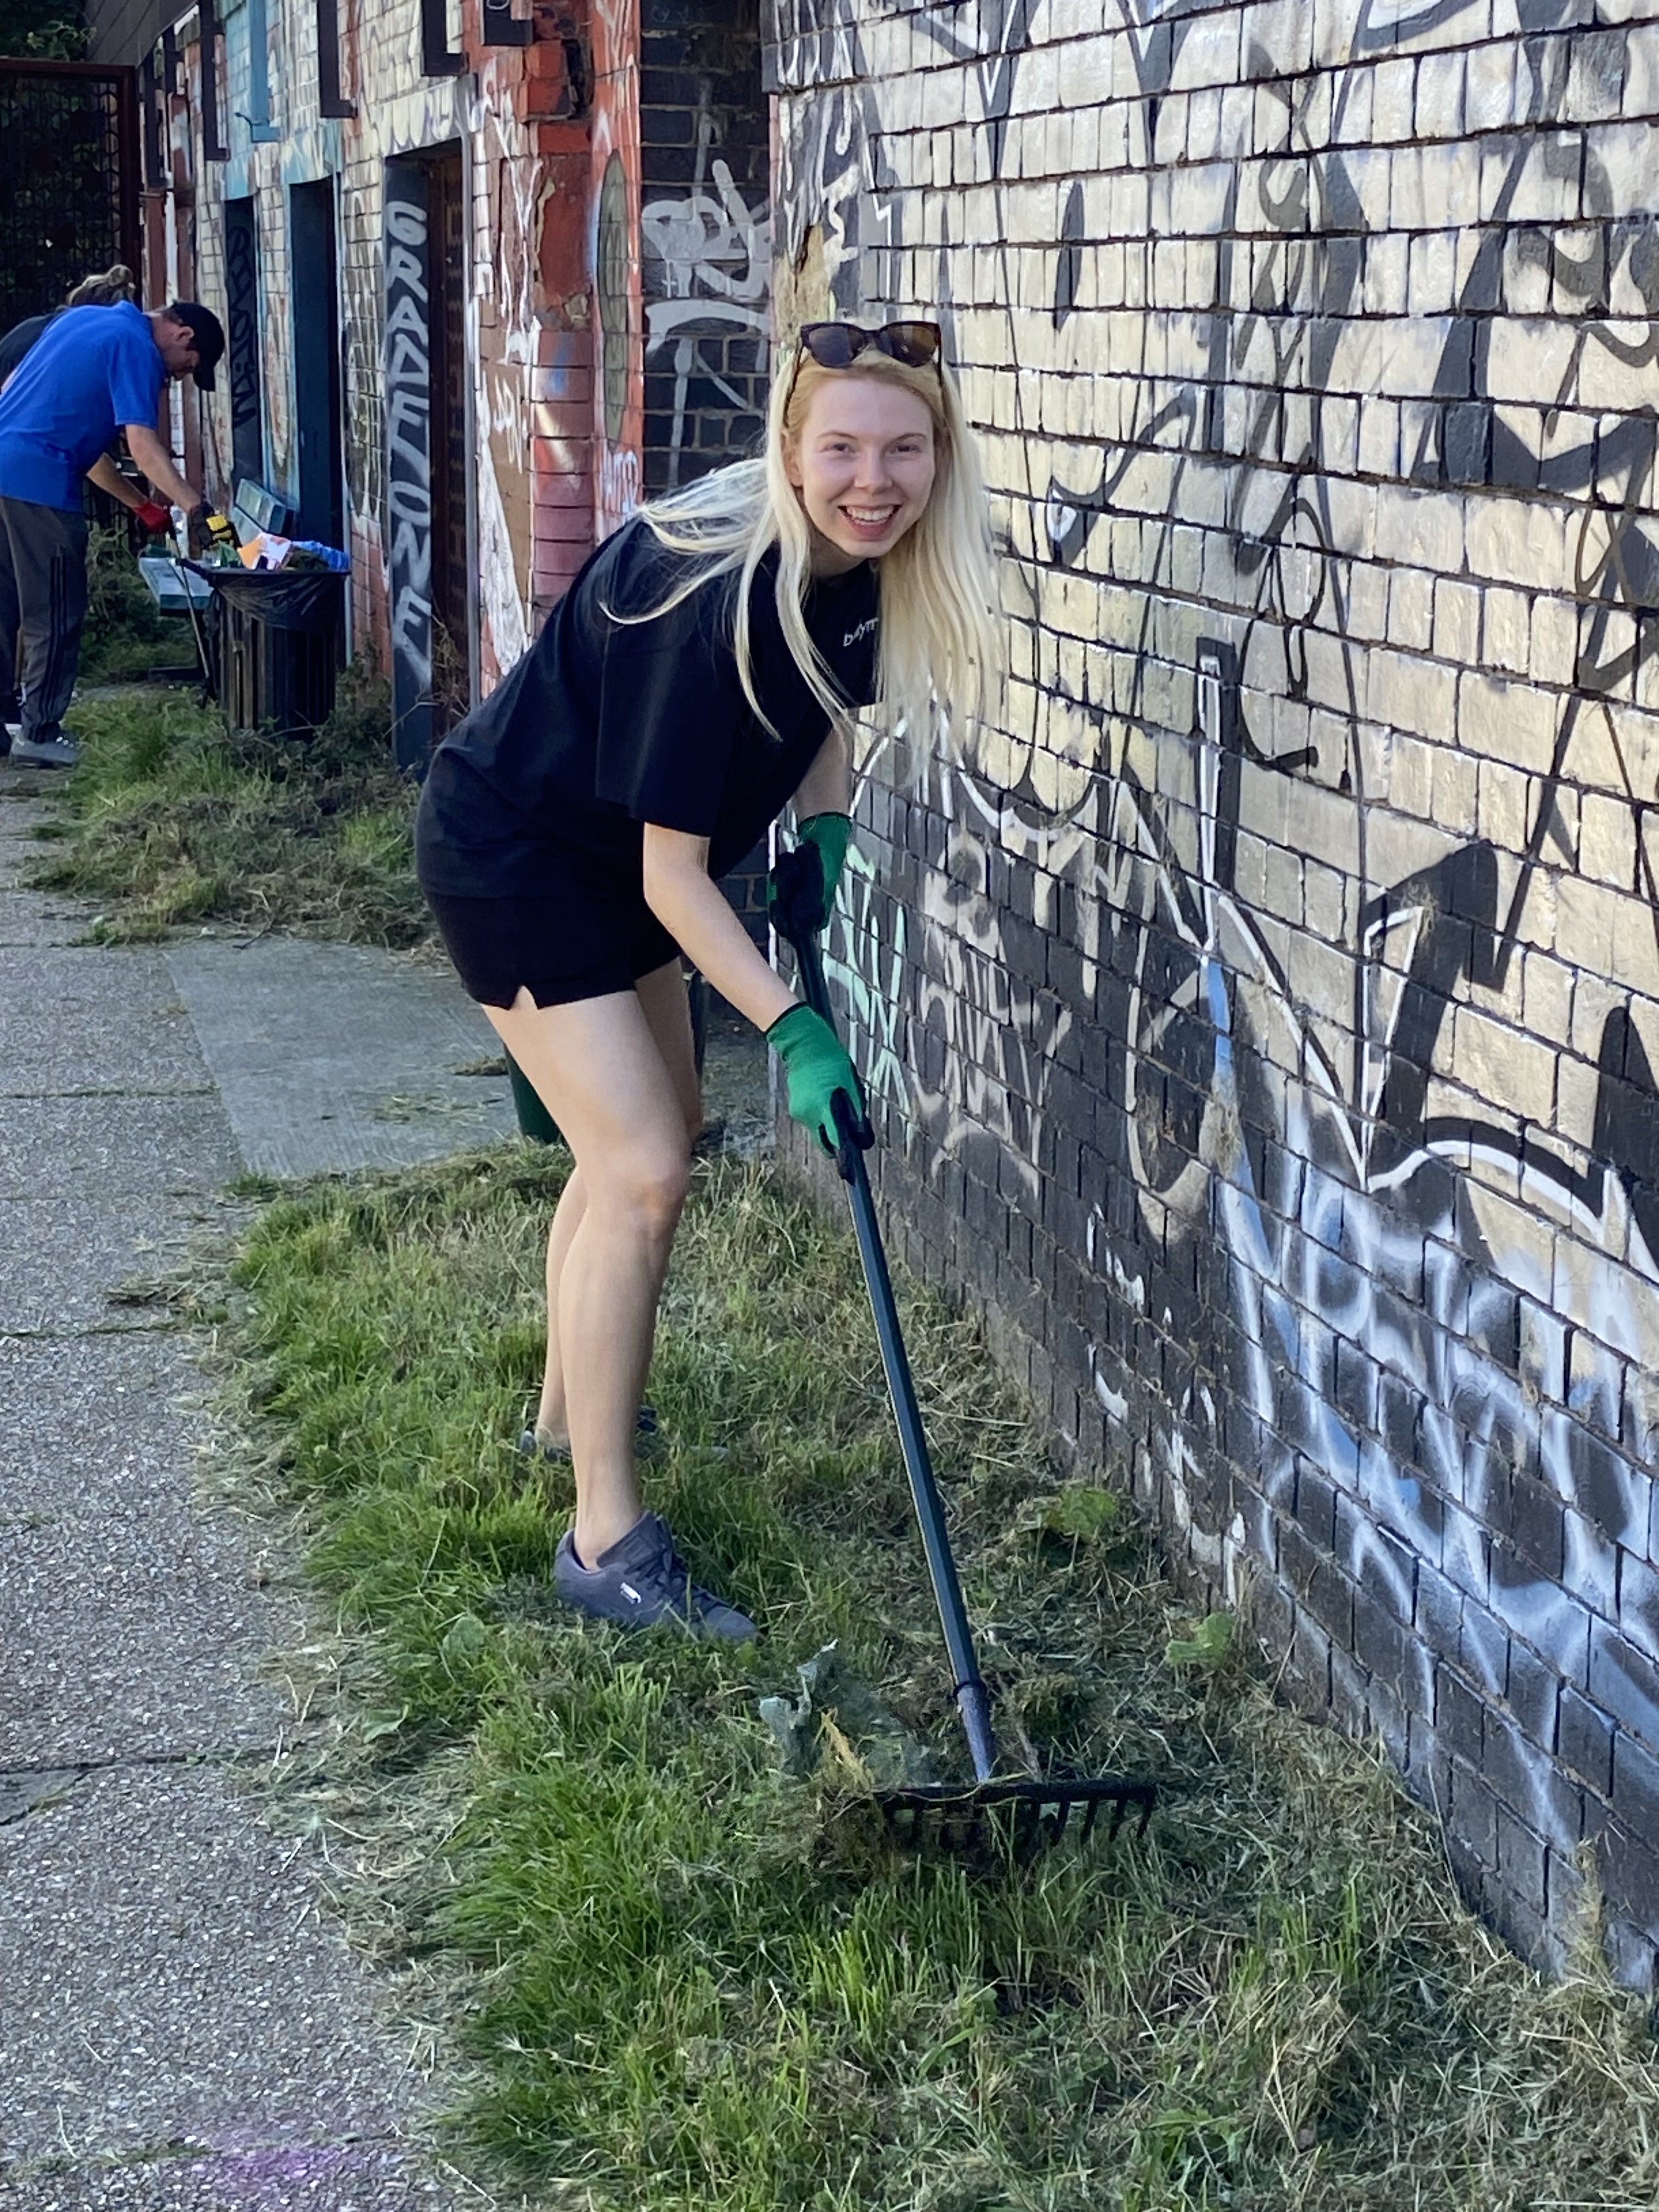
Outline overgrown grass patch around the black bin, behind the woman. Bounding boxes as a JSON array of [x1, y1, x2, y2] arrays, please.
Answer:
[[31, 670, 429, 947]]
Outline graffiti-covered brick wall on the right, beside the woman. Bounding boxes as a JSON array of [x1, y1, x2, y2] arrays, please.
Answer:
[[768, 0, 1659, 1984]]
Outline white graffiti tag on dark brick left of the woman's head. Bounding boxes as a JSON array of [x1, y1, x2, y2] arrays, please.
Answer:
[[639, 139, 772, 484]]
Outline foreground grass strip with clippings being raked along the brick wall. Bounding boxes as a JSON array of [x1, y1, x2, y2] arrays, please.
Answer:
[[218, 1148, 1659, 2212]]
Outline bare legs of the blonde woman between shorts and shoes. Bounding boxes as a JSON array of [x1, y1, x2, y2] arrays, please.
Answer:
[[484, 969, 697, 1564]]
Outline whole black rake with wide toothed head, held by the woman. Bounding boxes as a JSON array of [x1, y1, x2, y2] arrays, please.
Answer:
[[772, 845, 1157, 1860]]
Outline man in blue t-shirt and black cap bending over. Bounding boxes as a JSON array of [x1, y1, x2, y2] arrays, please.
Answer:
[[0, 301, 225, 768]]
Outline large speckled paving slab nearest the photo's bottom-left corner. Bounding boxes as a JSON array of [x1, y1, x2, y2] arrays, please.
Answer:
[[0, 1768, 455, 2176]]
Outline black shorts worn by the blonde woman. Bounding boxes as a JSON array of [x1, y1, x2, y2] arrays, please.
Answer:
[[427, 891, 679, 1007]]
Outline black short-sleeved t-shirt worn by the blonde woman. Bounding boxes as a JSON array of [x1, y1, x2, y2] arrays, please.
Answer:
[[416, 520, 878, 953]]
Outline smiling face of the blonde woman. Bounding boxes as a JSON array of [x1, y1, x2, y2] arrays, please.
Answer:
[[783, 374, 938, 575]]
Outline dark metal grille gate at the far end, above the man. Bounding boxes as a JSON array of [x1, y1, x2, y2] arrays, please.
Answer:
[[0, 60, 142, 330]]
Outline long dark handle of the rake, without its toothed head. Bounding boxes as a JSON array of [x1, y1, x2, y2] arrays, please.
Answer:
[[785, 929, 997, 1783]]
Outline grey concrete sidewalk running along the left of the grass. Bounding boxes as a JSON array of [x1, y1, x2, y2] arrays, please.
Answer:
[[0, 763, 513, 2212]]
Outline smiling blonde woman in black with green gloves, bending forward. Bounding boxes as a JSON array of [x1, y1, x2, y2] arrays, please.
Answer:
[[416, 321, 1000, 1639]]
